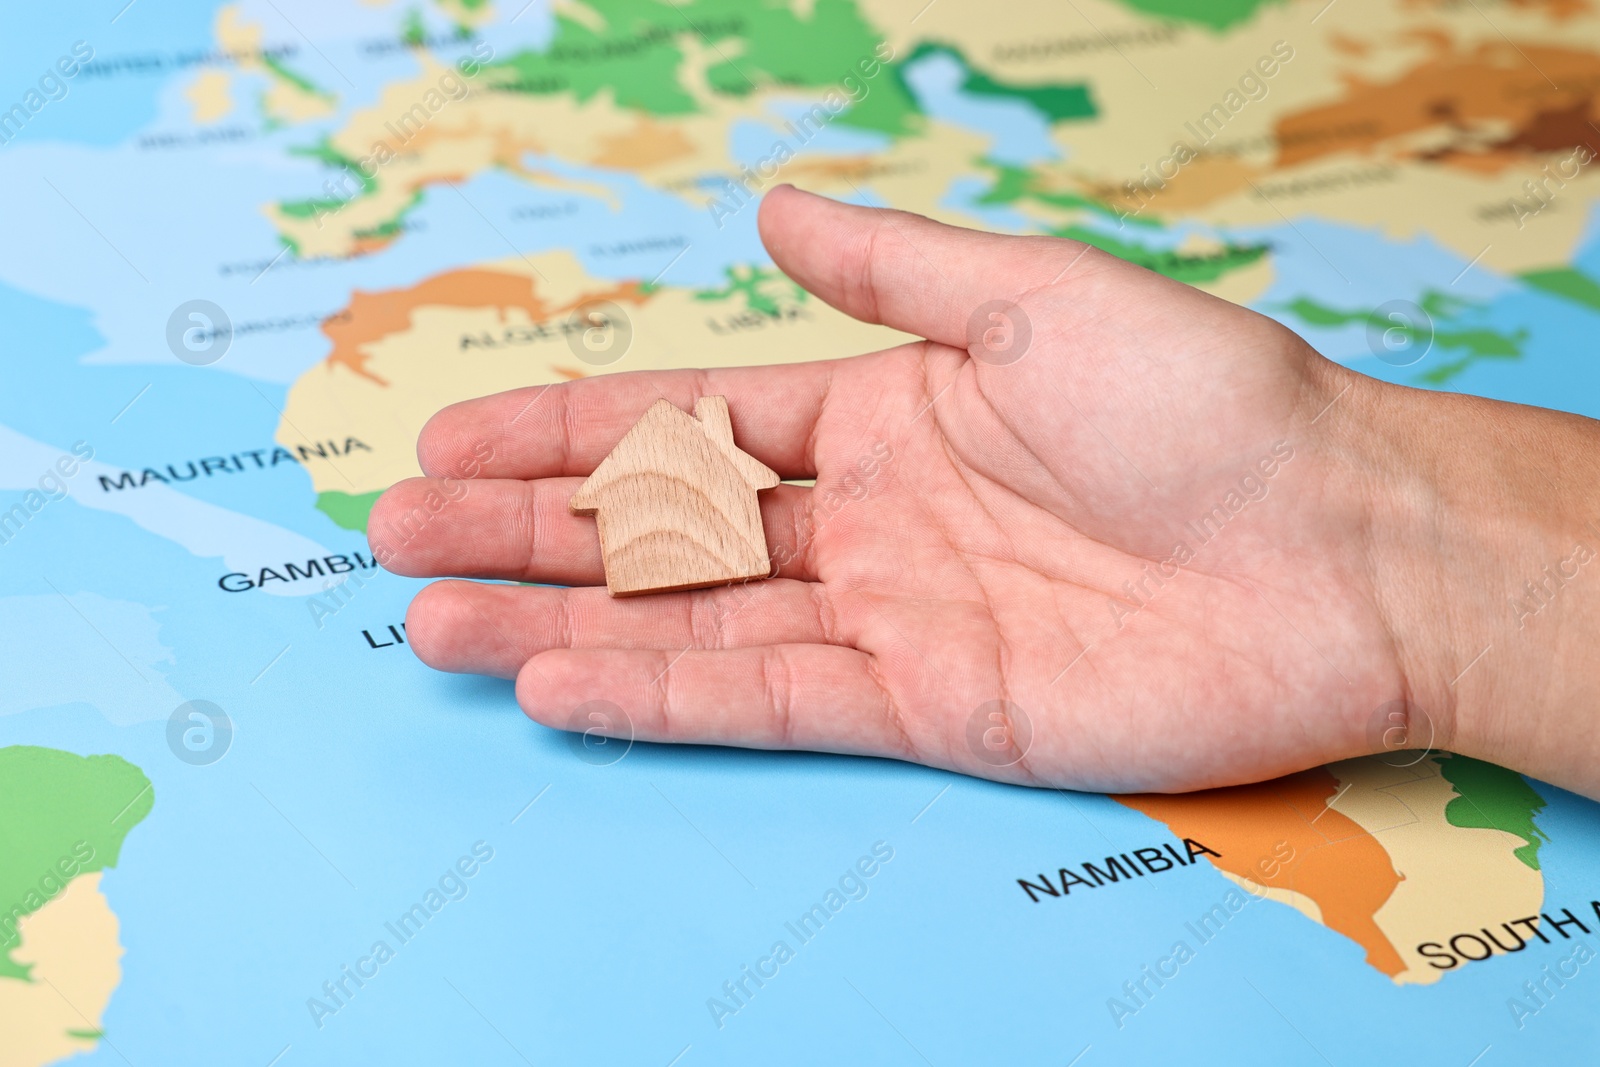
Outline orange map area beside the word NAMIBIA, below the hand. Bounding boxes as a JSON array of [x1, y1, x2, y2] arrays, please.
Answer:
[[1117, 768, 1405, 977]]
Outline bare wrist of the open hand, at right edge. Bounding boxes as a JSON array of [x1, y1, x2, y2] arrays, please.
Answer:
[[1339, 368, 1600, 793]]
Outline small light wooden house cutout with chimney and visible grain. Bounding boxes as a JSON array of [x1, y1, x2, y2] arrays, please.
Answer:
[[568, 397, 779, 597]]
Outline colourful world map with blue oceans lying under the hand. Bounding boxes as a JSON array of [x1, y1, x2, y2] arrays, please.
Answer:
[[0, 0, 1600, 1067]]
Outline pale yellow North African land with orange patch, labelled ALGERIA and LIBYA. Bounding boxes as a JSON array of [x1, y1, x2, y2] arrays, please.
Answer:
[[277, 253, 906, 496]]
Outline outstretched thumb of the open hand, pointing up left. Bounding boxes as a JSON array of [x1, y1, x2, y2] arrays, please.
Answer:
[[760, 186, 1154, 349]]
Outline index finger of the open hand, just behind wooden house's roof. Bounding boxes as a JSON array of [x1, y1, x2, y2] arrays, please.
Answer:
[[416, 360, 843, 478]]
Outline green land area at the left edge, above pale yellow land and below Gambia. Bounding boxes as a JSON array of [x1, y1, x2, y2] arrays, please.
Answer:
[[0, 745, 155, 981]]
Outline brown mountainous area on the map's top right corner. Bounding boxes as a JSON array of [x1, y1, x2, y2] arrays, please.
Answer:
[[1275, 35, 1600, 173]]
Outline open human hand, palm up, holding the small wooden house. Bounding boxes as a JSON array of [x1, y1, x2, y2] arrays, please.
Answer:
[[370, 187, 1600, 792]]
